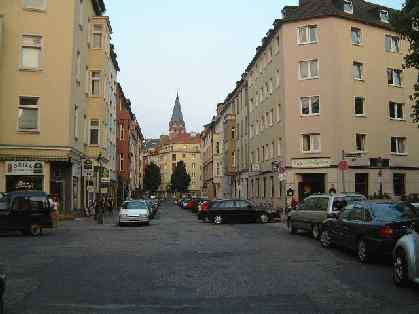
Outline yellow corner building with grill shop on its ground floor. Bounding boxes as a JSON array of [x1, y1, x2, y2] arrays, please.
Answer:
[[0, 0, 105, 211]]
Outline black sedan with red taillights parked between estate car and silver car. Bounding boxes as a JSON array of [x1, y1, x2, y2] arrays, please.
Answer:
[[320, 201, 419, 263]]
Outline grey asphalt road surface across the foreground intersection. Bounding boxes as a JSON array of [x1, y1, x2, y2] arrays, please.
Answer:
[[0, 204, 419, 314]]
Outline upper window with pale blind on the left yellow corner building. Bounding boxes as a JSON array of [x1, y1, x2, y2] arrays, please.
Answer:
[[20, 35, 42, 70]]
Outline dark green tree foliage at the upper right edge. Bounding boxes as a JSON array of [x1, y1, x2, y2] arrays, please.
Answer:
[[392, 0, 419, 122]]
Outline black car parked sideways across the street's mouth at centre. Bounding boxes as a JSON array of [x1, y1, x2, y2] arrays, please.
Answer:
[[202, 199, 273, 224]]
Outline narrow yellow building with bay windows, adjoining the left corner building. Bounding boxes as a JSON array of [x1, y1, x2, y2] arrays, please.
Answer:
[[86, 16, 119, 202]]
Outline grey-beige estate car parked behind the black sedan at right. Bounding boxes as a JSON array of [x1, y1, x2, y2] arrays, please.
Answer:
[[287, 193, 366, 239]]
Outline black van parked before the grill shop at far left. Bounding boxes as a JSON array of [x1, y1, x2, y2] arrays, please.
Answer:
[[0, 191, 53, 236]]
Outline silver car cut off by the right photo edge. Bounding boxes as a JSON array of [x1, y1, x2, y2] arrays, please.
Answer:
[[393, 224, 419, 287]]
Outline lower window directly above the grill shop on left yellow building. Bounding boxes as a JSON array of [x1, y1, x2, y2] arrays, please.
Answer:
[[17, 97, 39, 131]]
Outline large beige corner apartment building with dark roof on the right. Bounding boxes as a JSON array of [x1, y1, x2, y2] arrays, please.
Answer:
[[235, 0, 419, 203]]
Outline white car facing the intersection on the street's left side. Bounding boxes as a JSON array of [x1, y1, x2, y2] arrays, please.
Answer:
[[118, 200, 150, 226]]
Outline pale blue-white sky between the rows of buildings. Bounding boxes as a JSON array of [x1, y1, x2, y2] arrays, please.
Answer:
[[105, 0, 403, 138]]
